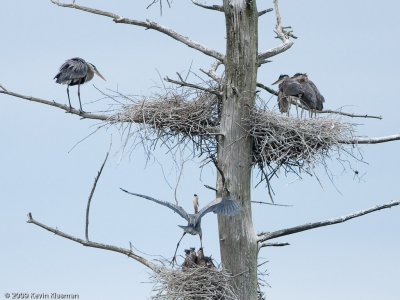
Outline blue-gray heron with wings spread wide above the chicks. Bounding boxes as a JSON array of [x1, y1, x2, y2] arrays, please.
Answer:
[[121, 188, 241, 261]]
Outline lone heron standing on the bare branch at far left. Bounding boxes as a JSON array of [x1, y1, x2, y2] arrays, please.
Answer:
[[54, 57, 106, 112]]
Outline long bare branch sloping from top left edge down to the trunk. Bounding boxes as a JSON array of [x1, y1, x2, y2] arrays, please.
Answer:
[[51, 0, 225, 61]]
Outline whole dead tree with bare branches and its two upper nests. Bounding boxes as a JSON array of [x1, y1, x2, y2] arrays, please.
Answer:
[[0, 0, 400, 299]]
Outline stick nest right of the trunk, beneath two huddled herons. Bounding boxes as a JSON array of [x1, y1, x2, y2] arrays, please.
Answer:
[[248, 109, 354, 170]]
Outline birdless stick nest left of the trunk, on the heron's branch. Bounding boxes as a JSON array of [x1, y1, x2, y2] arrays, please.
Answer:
[[117, 90, 219, 154]]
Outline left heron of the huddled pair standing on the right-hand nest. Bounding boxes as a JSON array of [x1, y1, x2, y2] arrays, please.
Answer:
[[272, 74, 304, 115]]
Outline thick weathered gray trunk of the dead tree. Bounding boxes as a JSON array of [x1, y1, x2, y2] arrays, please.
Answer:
[[217, 0, 258, 299]]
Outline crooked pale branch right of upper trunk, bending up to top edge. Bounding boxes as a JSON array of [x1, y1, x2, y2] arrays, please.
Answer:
[[258, 0, 294, 65]]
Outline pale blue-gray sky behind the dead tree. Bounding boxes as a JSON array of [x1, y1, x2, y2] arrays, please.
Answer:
[[0, 0, 400, 300]]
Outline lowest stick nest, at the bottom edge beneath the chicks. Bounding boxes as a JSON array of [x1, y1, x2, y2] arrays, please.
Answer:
[[150, 265, 239, 300]]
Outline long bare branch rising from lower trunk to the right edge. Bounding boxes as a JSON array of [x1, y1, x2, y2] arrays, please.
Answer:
[[258, 201, 400, 243]]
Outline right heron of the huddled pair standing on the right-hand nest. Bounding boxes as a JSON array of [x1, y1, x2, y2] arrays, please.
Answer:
[[292, 73, 325, 115]]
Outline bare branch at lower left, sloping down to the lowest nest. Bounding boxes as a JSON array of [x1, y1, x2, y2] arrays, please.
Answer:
[[27, 213, 162, 272]]
